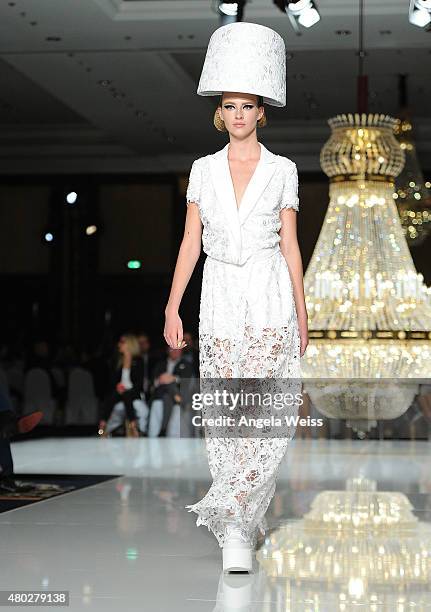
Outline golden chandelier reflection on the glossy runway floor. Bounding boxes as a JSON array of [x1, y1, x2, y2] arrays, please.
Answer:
[[257, 476, 431, 612]]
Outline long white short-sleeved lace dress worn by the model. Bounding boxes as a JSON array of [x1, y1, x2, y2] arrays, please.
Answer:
[[186, 143, 300, 546]]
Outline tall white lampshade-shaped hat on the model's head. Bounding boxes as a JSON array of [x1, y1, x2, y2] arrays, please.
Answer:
[[197, 21, 286, 106]]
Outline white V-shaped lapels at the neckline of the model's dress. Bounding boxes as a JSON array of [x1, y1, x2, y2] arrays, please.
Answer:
[[210, 143, 277, 244]]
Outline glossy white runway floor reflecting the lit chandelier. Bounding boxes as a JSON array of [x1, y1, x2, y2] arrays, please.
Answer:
[[0, 438, 431, 612]]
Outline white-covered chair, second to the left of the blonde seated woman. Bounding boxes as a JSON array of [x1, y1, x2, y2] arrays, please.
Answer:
[[23, 368, 56, 425]]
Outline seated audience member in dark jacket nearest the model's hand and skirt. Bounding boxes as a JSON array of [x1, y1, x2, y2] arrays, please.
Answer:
[[148, 347, 196, 437]]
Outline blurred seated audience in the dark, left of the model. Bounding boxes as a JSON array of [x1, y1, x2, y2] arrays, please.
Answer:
[[0, 328, 199, 437]]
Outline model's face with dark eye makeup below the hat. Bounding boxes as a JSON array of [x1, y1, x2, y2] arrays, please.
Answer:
[[217, 92, 264, 138]]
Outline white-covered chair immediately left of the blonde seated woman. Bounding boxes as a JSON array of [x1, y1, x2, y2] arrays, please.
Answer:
[[64, 368, 99, 425]]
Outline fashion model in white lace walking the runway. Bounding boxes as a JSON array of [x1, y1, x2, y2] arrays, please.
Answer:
[[164, 22, 308, 572]]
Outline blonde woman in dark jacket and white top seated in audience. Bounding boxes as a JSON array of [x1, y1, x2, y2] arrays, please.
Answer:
[[99, 334, 143, 438]]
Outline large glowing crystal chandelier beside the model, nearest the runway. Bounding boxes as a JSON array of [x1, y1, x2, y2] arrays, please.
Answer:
[[301, 114, 431, 390]]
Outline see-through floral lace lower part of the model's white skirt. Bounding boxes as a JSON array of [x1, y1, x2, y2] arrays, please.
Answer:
[[187, 322, 300, 547]]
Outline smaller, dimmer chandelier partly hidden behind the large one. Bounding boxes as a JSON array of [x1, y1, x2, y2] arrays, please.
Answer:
[[394, 119, 431, 246]]
